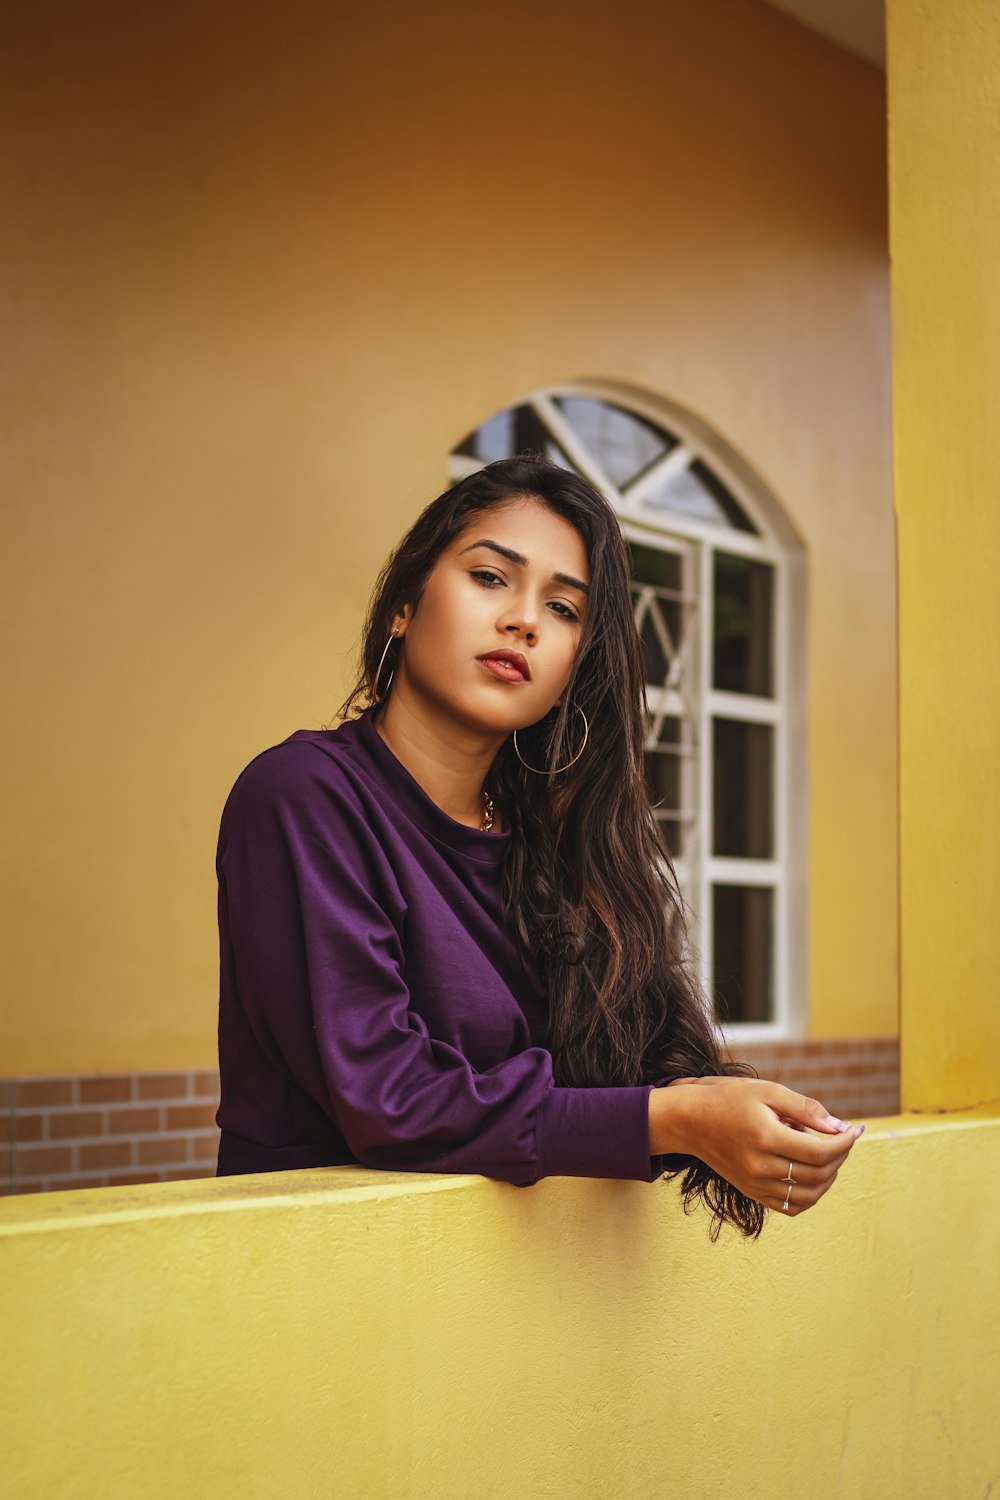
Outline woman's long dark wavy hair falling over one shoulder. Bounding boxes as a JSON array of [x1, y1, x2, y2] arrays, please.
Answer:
[[339, 453, 765, 1239]]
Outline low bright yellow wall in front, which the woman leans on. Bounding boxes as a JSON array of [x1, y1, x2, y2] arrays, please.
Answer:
[[0, 1116, 1000, 1500]]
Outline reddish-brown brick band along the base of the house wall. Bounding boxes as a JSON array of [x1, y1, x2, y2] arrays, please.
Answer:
[[0, 1037, 900, 1196]]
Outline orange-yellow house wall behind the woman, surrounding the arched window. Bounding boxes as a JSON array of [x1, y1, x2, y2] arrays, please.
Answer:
[[0, 0, 897, 1073]]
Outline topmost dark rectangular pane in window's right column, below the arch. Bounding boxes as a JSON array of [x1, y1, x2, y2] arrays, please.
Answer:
[[712, 552, 774, 698]]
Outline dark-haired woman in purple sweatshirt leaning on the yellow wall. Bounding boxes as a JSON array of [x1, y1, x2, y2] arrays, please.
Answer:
[[217, 456, 864, 1235]]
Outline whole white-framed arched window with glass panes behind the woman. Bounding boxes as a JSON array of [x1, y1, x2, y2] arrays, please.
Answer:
[[448, 383, 807, 1041]]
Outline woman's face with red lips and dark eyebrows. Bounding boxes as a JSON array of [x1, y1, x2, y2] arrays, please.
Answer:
[[393, 497, 591, 737]]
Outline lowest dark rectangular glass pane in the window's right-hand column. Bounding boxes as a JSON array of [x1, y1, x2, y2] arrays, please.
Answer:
[[712, 885, 774, 1022]]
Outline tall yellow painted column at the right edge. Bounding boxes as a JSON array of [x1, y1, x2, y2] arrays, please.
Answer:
[[886, 0, 1000, 1110]]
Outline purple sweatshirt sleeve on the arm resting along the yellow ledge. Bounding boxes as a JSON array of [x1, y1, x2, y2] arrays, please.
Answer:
[[219, 747, 660, 1184]]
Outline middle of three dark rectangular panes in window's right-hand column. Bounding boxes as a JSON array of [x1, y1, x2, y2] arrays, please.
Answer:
[[712, 719, 774, 860]]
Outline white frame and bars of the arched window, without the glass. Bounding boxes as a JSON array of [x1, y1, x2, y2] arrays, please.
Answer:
[[448, 381, 808, 1046]]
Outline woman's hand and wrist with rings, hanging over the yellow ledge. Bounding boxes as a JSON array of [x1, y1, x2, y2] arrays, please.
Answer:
[[649, 1077, 865, 1218]]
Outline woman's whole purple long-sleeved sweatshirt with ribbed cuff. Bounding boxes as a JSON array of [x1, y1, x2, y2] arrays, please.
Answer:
[[217, 710, 663, 1185]]
